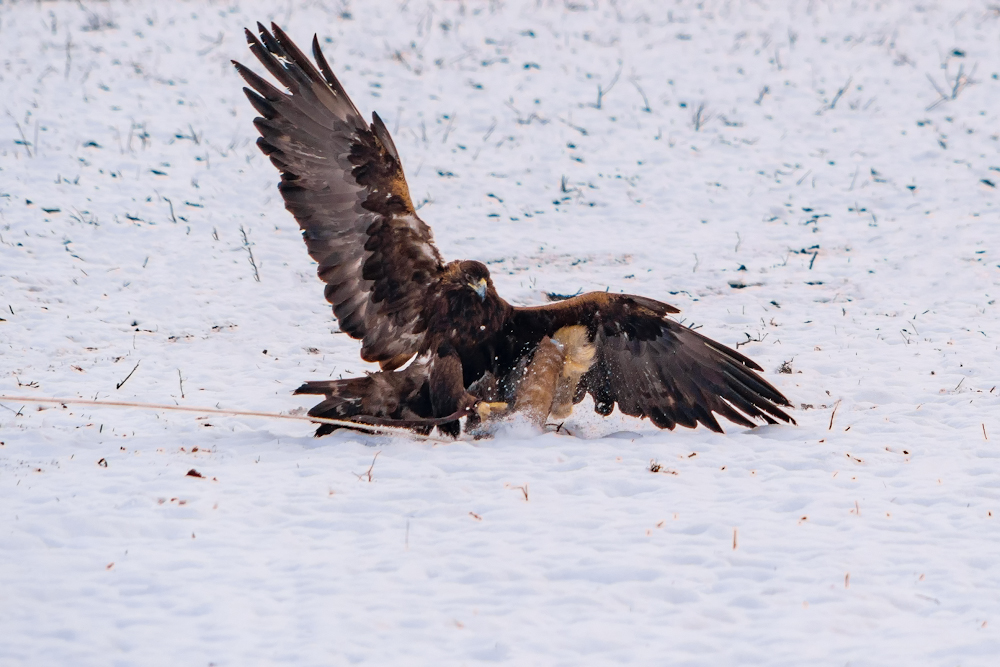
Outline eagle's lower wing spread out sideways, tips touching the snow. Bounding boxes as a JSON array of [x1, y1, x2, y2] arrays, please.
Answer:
[[507, 292, 795, 432]]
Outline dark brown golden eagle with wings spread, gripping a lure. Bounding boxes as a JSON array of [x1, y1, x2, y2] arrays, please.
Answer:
[[233, 23, 794, 435]]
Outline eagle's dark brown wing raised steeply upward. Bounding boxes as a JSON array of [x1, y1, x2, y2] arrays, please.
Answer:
[[233, 23, 442, 370]]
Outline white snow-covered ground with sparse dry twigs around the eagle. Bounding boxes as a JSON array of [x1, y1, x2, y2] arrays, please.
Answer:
[[0, 0, 1000, 666]]
